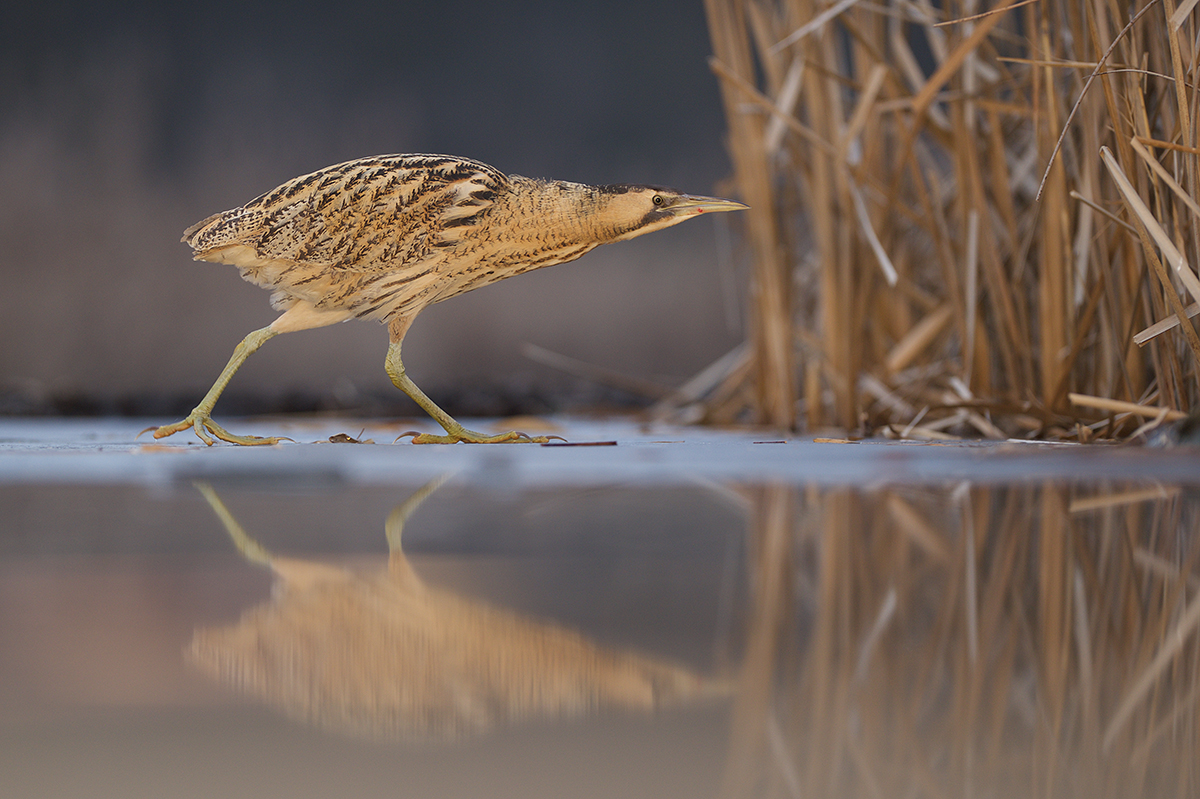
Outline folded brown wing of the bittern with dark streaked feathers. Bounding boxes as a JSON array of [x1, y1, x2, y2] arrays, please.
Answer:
[[184, 155, 509, 272]]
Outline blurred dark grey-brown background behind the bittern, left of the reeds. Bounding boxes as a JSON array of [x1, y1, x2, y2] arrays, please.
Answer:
[[0, 0, 740, 415]]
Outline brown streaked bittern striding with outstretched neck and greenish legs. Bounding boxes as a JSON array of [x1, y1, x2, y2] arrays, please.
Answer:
[[154, 155, 746, 445]]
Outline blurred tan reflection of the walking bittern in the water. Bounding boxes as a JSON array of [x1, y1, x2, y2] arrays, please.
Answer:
[[187, 472, 728, 741]]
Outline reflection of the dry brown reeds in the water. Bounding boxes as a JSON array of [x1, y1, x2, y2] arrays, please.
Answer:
[[721, 485, 1200, 798]]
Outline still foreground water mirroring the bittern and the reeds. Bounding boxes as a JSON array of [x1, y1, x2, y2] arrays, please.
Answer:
[[0, 467, 1200, 799]]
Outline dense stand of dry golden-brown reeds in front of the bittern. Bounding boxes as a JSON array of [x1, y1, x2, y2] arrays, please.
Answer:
[[696, 0, 1200, 441]]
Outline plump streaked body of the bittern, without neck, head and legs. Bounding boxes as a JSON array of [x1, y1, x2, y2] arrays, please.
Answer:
[[182, 155, 510, 318]]
